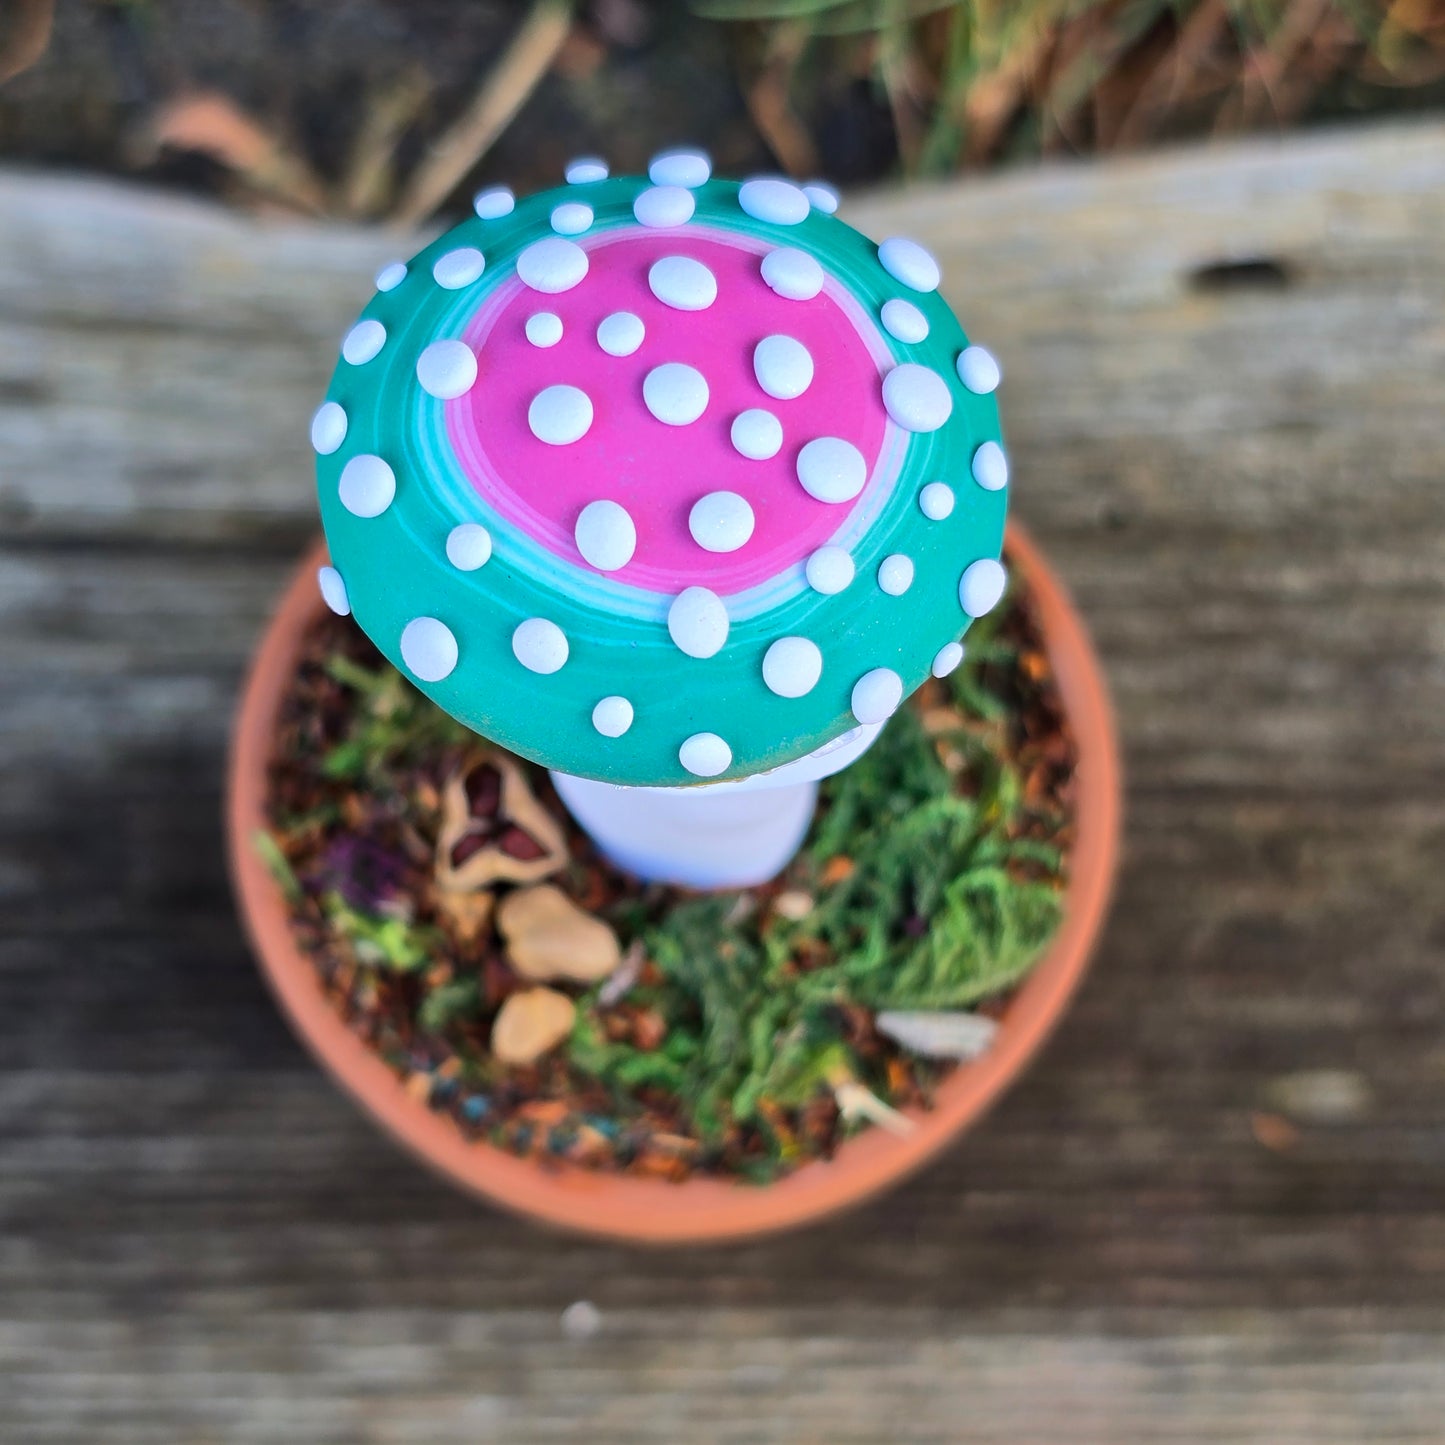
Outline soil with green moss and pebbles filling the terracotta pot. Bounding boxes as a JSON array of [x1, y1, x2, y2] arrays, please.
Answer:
[[254, 554, 1075, 1183]]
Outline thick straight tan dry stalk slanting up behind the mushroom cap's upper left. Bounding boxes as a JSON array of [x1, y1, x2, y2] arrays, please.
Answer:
[[392, 0, 572, 230]]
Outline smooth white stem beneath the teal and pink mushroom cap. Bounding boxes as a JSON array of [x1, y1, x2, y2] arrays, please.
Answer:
[[552, 723, 883, 889]]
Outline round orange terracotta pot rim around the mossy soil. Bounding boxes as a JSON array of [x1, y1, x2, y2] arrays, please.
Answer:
[[227, 525, 1120, 1244]]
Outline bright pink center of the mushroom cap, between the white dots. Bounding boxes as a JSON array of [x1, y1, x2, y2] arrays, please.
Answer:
[[445, 225, 890, 595]]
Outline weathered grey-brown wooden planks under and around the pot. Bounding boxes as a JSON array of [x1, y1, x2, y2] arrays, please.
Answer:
[[0, 123, 1445, 1445]]
